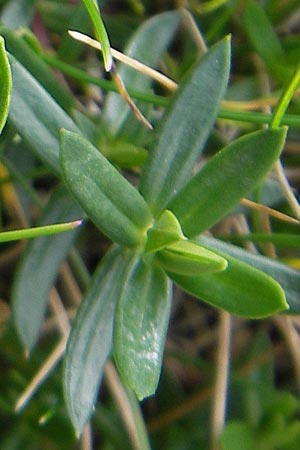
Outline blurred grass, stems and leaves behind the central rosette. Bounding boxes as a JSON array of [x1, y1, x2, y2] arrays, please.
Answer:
[[0, 0, 300, 450]]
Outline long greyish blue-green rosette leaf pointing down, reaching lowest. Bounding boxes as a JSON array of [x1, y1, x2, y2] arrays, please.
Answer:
[[63, 247, 126, 435]]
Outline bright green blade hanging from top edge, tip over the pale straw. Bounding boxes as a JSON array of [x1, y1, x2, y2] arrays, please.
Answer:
[[82, 0, 113, 72]]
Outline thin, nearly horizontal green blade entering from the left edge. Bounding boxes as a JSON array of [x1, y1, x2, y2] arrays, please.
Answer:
[[0, 220, 82, 242]]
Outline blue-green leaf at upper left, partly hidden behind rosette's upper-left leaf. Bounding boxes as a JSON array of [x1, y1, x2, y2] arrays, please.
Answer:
[[9, 56, 78, 173]]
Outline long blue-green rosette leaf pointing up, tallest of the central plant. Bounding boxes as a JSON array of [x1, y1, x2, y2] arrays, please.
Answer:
[[140, 38, 230, 217]]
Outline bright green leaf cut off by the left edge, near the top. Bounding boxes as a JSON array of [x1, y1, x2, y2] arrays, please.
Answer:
[[0, 36, 11, 134]]
